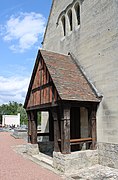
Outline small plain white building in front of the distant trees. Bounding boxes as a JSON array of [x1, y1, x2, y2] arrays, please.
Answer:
[[2, 113, 20, 127]]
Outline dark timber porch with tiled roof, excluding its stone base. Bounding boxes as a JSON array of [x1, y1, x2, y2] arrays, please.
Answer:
[[24, 50, 100, 154]]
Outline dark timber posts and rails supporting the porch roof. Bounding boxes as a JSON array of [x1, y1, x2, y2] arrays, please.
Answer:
[[27, 101, 97, 153]]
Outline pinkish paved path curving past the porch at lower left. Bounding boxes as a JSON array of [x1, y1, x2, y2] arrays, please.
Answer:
[[0, 132, 62, 180]]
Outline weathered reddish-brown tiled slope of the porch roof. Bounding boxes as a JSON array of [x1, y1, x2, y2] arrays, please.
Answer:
[[40, 50, 99, 102]]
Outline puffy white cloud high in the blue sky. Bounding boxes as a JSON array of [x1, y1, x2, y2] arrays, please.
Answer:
[[1, 12, 46, 52]]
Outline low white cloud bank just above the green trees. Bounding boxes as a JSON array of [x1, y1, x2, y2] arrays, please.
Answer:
[[0, 76, 29, 104]]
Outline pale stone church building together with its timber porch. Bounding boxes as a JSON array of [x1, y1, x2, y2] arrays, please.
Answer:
[[24, 0, 118, 172]]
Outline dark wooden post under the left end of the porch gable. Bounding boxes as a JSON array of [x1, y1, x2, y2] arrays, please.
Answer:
[[31, 111, 37, 144]]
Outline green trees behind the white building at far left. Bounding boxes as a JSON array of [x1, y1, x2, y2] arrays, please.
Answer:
[[0, 101, 27, 124]]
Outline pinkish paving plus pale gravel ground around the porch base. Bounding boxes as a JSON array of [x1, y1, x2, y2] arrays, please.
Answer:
[[0, 132, 118, 180]]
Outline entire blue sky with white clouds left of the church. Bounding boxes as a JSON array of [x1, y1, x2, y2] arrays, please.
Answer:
[[0, 0, 52, 105]]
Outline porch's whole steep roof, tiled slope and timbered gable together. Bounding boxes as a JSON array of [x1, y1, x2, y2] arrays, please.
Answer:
[[25, 50, 99, 109]]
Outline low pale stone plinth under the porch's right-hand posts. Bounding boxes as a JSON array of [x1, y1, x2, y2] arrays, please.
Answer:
[[53, 150, 98, 174]]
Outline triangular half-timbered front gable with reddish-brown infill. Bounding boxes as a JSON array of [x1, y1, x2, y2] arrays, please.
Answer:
[[25, 51, 59, 109]]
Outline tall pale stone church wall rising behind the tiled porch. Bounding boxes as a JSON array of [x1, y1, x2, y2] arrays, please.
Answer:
[[43, 0, 118, 144]]
